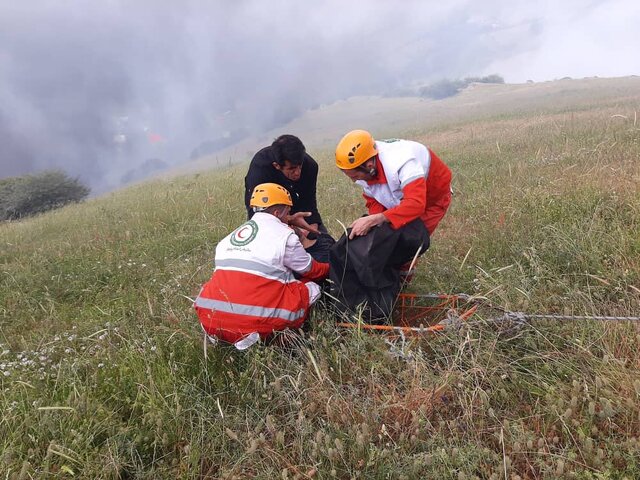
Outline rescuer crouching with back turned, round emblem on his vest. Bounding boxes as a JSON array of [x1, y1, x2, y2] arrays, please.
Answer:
[[194, 183, 329, 349]]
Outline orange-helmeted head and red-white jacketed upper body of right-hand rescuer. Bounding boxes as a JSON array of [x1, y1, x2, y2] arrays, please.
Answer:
[[336, 130, 451, 278]]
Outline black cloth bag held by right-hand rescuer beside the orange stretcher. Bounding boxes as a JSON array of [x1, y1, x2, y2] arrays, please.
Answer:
[[329, 219, 429, 322]]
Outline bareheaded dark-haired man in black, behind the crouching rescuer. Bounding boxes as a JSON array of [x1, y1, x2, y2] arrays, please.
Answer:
[[244, 135, 334, 262]]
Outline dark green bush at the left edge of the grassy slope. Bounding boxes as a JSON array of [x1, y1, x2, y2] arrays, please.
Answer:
[[0, 170, 90, 221]]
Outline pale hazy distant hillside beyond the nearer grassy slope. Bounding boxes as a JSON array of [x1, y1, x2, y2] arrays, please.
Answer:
[[176, 76, 640, 174]]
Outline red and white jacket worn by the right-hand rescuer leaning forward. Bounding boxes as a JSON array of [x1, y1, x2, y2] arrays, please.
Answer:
[[356, 139, 451, 233]]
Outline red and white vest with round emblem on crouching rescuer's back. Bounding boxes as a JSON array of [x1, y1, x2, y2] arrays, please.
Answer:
[[194, 213, 316, 343]]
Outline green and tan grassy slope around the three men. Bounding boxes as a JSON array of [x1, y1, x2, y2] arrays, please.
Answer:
[[0, 79, 640, 478]]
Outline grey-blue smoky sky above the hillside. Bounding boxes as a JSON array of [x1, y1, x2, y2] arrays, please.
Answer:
[[0, 0, 640, 192]]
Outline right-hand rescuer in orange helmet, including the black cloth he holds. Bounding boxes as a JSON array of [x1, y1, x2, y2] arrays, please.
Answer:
[[330, 130, 451, 321]]
